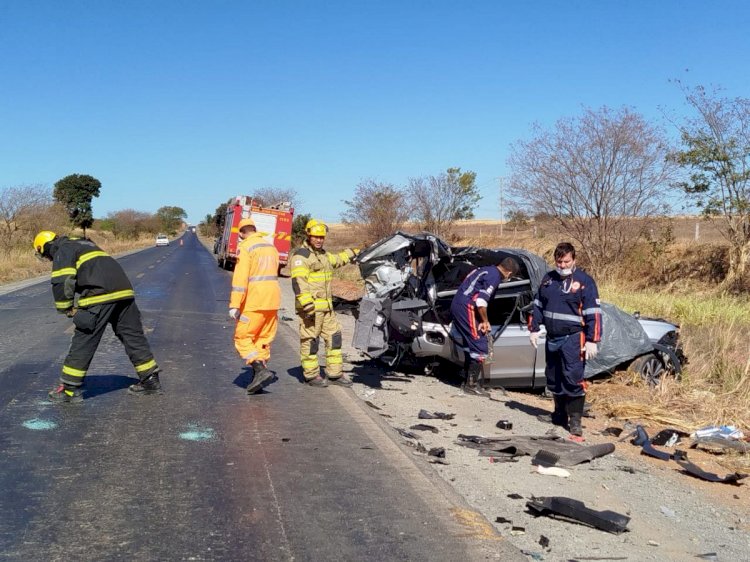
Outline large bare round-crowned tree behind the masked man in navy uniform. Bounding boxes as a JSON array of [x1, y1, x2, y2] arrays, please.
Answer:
[[509, 107, 675, 274]]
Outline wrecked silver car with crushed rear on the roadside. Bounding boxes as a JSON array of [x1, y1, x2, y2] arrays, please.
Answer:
[[354, 232, 684, 388]]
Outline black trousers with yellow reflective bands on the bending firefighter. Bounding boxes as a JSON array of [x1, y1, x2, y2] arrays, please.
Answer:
[[60, 299, 158, 386]]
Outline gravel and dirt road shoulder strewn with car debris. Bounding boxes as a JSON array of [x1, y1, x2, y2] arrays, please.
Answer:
[[335, 282, 750, 560]]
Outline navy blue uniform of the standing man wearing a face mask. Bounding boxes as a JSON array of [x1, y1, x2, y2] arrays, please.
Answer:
[[529, 269, 602, 396]]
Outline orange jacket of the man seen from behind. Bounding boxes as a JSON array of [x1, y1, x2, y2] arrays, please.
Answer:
[[229, 232, 281, 312]]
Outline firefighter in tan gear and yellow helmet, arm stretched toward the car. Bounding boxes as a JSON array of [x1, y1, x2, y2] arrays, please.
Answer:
[[291, 219, 359, 386]]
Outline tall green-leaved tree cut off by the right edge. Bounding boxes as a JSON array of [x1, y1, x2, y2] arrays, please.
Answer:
[[671, 85, 750, 289]]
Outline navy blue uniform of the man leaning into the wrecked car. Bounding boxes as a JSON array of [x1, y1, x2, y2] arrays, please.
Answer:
[[451, 265, 503, 363]]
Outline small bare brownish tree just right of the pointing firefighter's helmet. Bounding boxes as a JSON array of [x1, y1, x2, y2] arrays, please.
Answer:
[[342, 179, 410, 242]]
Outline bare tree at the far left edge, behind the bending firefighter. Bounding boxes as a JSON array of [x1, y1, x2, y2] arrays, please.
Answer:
[[0, 185, 53, 248]]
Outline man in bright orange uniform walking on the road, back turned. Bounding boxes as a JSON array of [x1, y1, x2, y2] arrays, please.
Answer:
[[229, 218, 281, 394]]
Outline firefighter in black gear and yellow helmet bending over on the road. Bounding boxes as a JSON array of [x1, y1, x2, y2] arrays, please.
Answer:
[[34, 230, 161, 402]]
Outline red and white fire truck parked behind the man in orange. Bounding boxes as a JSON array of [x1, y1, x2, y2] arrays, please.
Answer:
[[214, 195, 294, 269]]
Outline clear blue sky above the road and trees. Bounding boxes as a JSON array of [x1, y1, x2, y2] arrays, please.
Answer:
[[0, 0, 750, 222]]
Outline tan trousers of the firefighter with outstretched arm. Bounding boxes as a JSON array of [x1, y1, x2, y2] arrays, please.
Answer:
[[299, 311, 343, 381]]
